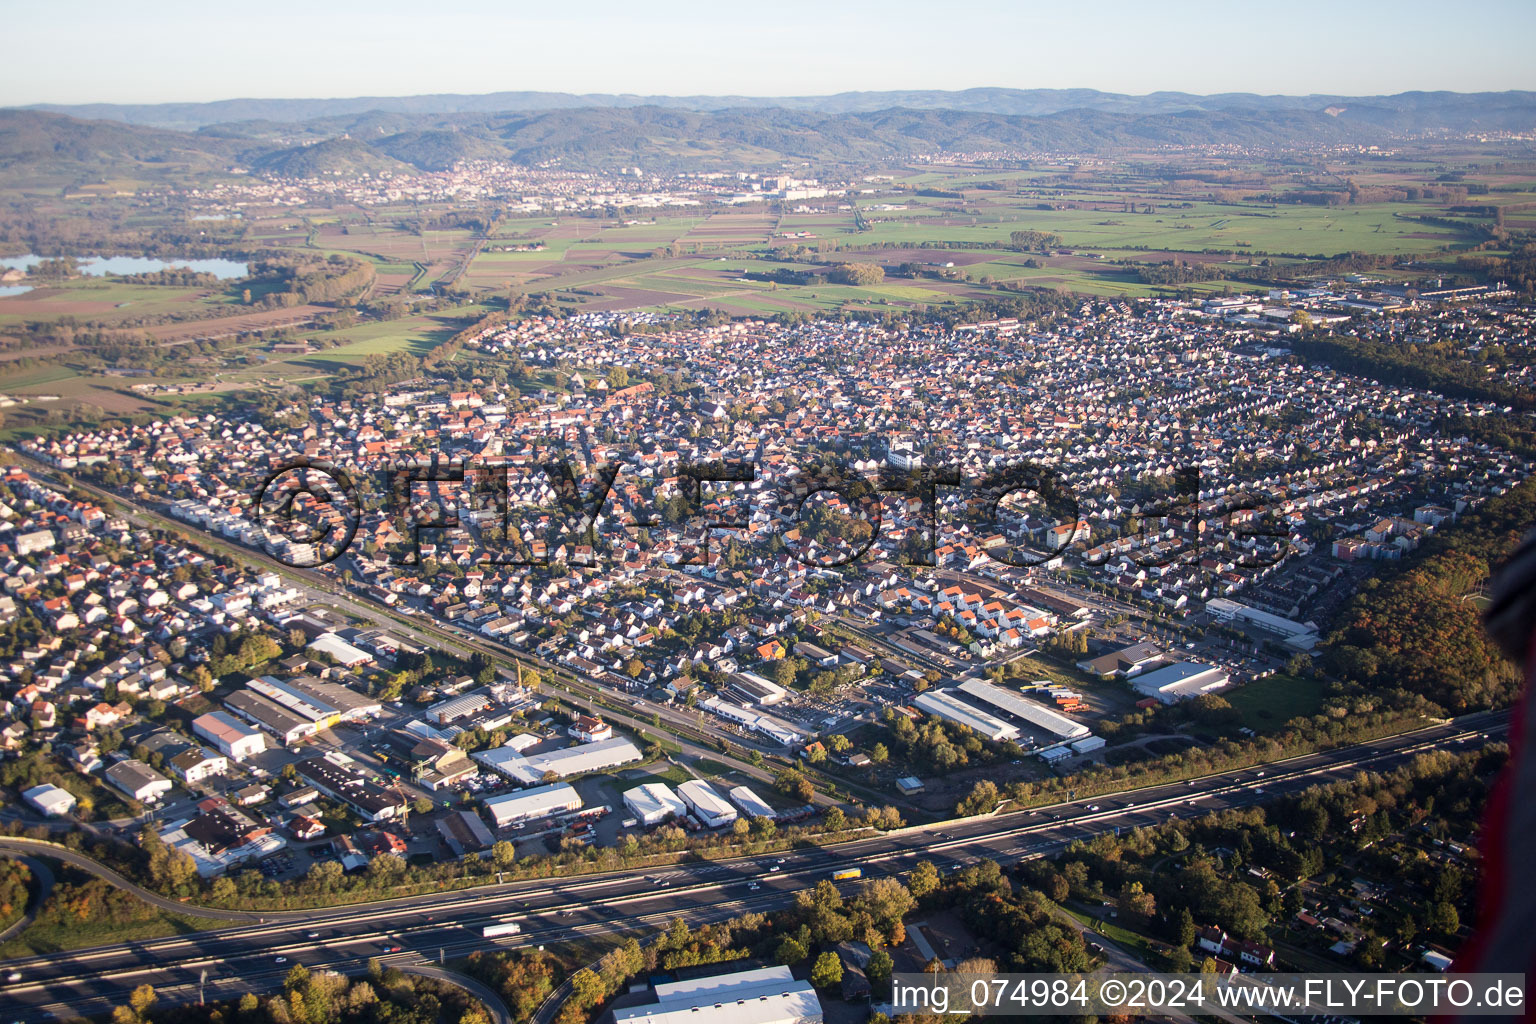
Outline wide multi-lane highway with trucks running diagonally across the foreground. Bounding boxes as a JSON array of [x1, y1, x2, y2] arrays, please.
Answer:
[[0, 712, 1507, 1022]]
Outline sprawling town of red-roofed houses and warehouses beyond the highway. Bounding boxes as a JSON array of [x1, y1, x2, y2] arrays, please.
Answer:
[[9, 281, 1530, 877]]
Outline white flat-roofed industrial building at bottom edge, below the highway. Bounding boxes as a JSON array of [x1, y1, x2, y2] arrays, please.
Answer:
[[611, 967, 823, 1024]]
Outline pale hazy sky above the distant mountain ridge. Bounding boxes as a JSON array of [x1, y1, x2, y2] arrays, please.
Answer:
[[0, 0, 1536, 106]]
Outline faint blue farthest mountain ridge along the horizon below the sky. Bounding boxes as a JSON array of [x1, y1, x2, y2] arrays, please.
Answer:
[[26, 89, 1536, 130]]
